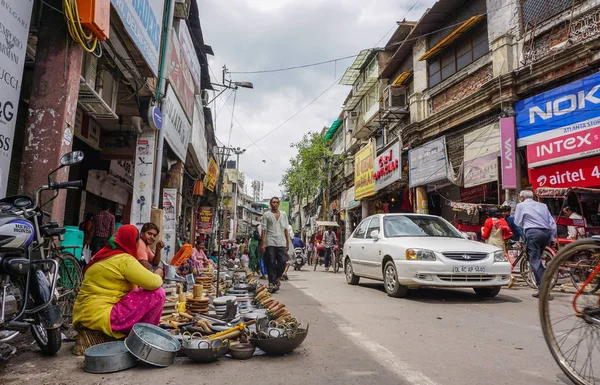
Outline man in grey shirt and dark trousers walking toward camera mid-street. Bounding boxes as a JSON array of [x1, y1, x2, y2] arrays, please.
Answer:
[[260, 197, 290, 293]]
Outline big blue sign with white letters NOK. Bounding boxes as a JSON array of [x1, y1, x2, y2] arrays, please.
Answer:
[[515, 73, 600, 147]]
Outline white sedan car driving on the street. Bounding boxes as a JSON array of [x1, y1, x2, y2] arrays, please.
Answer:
[[344, 214, 511, 297]]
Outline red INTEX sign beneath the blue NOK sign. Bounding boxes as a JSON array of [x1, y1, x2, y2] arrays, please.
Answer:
[[527, 127, 600, 167]]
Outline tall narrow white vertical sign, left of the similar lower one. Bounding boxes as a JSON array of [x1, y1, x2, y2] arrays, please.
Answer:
[[131, 130, 156, 230]]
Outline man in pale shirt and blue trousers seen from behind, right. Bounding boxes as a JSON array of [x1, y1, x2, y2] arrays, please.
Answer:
[[515, 190, 556, 298]]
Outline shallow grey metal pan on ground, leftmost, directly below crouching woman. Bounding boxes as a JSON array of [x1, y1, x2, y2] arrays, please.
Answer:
[[83, 341, 138, 374]]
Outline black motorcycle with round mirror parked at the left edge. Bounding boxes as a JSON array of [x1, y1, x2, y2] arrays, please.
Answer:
[[0, 151, 83, 358]]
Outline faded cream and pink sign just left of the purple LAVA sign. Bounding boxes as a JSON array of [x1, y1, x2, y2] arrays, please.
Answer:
[[464, 123, 500, 187]]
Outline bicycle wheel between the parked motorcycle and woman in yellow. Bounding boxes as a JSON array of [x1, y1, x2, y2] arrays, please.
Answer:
[[54, 253, 83, 327]]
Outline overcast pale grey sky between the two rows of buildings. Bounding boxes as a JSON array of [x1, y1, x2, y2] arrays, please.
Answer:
[[199, 0, 435, 198]]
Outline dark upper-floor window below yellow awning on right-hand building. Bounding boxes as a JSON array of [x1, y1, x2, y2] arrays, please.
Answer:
[[428, 26, 490, 87]]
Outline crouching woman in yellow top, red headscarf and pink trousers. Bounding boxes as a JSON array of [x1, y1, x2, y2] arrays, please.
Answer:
[[73, 225, 165, 338]]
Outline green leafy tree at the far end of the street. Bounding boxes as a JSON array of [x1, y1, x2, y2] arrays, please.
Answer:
[[280, 132, 331, 200]]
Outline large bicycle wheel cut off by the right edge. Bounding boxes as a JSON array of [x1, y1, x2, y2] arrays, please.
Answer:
[[539, 239, 600, 385]]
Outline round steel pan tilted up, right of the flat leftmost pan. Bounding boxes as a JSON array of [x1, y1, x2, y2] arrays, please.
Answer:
[[125, 323, 181, 367]]
